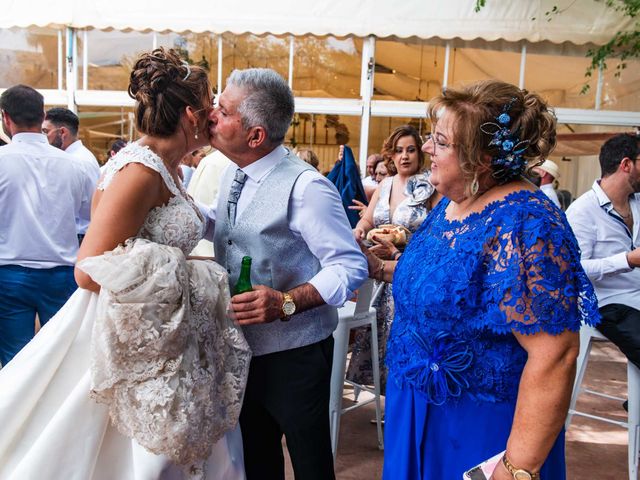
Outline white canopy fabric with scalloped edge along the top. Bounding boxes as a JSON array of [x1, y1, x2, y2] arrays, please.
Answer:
[[0, 0, 634, 45]]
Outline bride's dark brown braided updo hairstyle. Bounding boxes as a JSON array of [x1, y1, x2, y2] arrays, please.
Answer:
[[128, 47, 212, 137]]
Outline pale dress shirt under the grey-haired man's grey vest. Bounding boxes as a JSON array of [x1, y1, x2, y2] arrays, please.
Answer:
[[201, 146, 368, 307]]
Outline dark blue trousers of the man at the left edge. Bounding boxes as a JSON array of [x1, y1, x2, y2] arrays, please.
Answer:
[[0, 265, 78, 365]]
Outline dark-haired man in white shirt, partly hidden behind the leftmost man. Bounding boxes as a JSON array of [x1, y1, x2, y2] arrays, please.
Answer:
[[42, 107, 100, 243]]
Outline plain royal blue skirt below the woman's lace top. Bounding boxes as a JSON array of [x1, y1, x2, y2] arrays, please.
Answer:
[[383, 382, 566, 480]]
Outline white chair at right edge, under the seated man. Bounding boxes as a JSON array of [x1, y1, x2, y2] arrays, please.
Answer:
[[565, 325, 640, 480]]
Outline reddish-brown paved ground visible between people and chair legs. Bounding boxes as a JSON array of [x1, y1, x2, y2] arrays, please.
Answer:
[[287, 343, 627, 480]]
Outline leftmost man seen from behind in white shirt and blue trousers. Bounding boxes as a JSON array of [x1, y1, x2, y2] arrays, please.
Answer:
[[0, 85, 91, 365]]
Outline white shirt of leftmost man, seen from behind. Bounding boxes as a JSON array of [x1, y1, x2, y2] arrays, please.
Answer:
[[0, 133, 91, 268]]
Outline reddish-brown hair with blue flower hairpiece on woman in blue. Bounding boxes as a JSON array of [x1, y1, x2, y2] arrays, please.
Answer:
[[428, 80, 556, 185]]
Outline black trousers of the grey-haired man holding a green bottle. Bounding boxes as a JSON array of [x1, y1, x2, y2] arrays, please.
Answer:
[[240, 336, 335, 480]]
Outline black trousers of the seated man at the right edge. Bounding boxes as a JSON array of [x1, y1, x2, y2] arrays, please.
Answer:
[[598, 303, 640, 368]]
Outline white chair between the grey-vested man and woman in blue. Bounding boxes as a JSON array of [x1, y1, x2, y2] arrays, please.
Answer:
[[329, 280, 383, 459]]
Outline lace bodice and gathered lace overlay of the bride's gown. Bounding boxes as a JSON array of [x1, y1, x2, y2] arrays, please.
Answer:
[[78, 144, 251, 472]]
